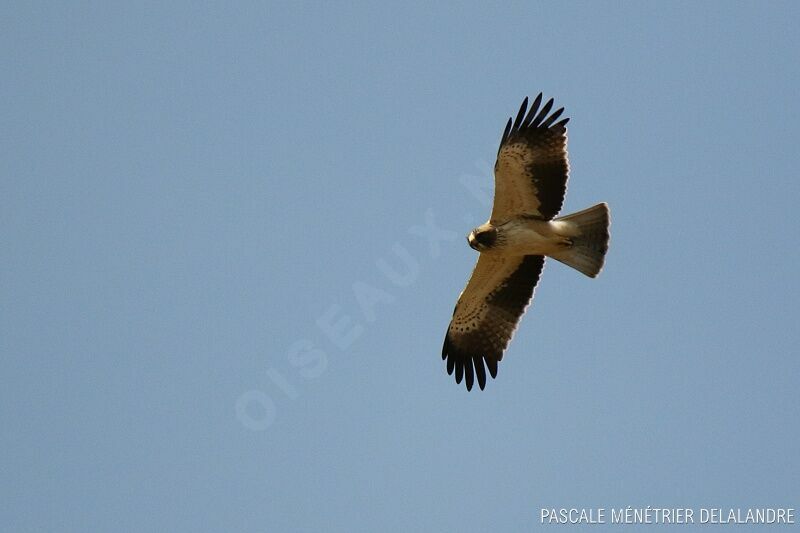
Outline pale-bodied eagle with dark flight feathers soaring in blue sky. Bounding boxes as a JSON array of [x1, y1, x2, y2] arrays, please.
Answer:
[[442, 93, 609, 390]]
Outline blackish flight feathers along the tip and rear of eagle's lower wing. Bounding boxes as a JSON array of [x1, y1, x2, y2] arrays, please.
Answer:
[[442, 255, 544, 390]]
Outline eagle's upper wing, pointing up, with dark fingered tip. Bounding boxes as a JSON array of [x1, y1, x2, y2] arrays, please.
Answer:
[[491, 93, 569, 223]]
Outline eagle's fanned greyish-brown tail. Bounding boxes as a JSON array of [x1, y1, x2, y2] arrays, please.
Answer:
[[551, 203, 609, 278]]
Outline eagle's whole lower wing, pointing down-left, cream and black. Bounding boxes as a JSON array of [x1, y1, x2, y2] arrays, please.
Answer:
[[442, 253, 544, 390]]
